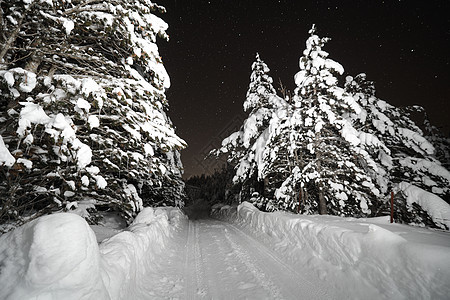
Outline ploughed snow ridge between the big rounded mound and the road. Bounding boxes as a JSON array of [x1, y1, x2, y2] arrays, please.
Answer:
[[100, 207, 186, 299]]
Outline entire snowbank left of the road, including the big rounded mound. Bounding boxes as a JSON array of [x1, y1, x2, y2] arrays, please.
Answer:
[[0, 208, 185, 299]]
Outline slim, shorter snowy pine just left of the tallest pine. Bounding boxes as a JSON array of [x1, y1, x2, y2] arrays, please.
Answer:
[[214, 54, 285, 203]]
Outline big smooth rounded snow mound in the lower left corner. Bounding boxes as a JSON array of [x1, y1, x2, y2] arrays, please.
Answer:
[[0, 213, 107, 299]]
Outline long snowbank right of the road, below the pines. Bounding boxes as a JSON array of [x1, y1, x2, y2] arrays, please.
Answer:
[[213, 202, 450, 299]]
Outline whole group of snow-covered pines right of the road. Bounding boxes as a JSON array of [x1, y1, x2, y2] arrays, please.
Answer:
[[212, 26, 450, 228]]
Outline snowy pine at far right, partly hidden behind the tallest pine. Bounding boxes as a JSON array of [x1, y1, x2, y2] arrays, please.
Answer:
[[345, 74, 450, 203]]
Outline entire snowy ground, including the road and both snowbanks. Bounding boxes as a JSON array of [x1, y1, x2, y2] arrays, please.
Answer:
[[0, 202, 450, 299]]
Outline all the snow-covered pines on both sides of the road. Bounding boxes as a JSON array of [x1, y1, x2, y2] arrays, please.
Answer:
[[0, 0, 450, 231]]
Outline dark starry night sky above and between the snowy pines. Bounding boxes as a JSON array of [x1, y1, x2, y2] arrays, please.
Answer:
[[156, 0, 450, 177]]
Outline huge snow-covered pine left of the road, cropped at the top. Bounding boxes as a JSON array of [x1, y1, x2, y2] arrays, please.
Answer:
[[0, 0, 185, 226]]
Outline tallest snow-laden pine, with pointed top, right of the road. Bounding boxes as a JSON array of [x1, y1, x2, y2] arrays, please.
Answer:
[[276, 26, 379, 216]]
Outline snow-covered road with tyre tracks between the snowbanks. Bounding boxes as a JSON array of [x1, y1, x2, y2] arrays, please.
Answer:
[[149, 219, 330, 299]]
